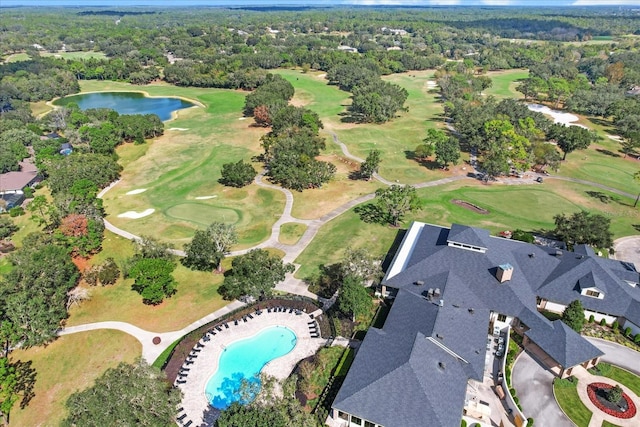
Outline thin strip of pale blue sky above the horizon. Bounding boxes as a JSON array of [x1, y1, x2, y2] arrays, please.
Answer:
[[0, 0, 640, 9]]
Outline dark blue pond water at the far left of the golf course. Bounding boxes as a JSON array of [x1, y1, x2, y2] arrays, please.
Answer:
[[53, 92, 195, 121]]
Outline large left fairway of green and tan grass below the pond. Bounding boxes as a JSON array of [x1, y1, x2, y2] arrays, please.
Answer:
[[72, 81, 284, 248]]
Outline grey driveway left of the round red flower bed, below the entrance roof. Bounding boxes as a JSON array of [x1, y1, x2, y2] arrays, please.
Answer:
[[511, 352, 575, 427]]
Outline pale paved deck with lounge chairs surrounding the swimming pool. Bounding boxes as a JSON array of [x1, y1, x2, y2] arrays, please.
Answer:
[[176, 310, 326, 426]]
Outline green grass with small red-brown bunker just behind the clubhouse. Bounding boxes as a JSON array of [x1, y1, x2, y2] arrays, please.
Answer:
[[296, 179, 640, 278]]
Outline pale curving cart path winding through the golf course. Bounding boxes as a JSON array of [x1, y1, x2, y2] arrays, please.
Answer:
[[58, 128, 635, 363]]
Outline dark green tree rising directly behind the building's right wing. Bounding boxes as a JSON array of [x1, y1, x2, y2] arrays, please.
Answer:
[[553, 211, 613, 248]]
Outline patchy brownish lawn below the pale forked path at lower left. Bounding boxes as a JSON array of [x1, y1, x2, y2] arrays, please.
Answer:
[[11, 330, 142, 426]]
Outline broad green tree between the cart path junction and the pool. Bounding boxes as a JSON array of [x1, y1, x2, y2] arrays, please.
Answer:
[[220, 249, 294, 299]]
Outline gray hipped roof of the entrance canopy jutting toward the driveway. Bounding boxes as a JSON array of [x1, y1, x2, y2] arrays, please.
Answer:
[[525, 320, 604, 368]]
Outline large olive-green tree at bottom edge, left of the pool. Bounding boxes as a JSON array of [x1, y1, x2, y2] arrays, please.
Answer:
[[62, 361, 181, 427]]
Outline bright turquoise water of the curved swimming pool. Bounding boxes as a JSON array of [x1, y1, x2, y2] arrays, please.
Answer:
[[205, 326, 297, 409]]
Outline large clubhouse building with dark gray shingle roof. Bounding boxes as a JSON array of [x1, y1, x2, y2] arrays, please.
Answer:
[[331, 222, 640, 427]]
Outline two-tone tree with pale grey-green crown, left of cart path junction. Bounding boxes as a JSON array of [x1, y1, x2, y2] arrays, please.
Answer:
[[182, 221, 238, 271]]
